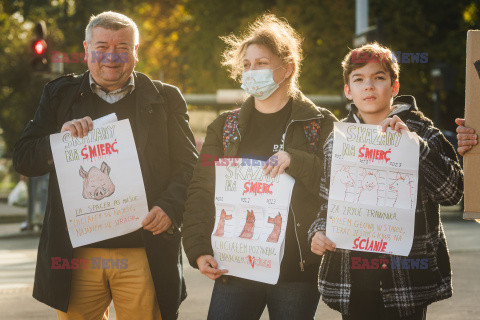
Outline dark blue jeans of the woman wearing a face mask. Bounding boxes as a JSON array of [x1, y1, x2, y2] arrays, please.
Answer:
[[208, 276, 320, 320]]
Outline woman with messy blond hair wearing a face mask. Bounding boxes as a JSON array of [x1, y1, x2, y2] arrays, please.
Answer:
[[183, 14, 336, 319]]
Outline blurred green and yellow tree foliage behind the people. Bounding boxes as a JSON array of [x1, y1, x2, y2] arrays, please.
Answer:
[[0, 0, 480, 155]]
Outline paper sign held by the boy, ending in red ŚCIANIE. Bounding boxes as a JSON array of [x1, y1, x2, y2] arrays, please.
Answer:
[[326, 122, 420, 256]]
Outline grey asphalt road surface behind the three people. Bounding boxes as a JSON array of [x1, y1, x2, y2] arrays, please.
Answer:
[[0, 214, 480, 320]]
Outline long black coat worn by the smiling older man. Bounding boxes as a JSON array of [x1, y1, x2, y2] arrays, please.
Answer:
[[13, 72, 197, 320]]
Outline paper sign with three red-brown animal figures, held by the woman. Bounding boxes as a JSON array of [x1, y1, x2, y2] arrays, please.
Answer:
[[215, 158, 295, 284]]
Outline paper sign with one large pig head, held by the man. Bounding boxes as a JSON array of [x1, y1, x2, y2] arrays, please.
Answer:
[[50, 120, 148, 248]]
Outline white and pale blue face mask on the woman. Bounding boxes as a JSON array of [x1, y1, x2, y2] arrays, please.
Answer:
[[241, 66, 285, 100]]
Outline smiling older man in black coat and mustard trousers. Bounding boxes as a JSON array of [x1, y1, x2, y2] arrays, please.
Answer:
[[13, 12, 197, 320]]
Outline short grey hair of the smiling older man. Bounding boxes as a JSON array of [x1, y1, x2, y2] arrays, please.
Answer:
[[85, 11, 139, 46]]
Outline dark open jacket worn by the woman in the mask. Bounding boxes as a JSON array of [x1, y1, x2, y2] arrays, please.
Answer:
[[183, 92, 337, 278]]
